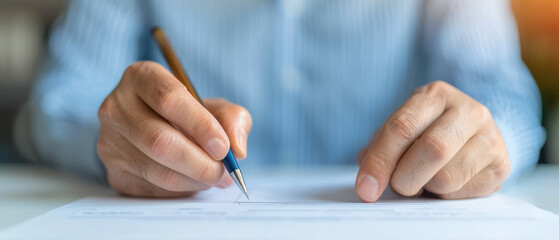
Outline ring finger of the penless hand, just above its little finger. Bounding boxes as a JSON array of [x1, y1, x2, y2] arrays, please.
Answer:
[[425, 134, 497, 194]]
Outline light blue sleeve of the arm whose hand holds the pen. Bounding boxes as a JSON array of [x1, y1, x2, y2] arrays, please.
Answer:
[[15, 0, 149, 179]]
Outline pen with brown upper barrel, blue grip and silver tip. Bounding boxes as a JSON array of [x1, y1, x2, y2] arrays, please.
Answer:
[[151, 27, 249, 199]]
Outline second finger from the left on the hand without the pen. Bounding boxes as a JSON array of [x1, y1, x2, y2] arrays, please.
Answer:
[[390, 104, 485, 196]]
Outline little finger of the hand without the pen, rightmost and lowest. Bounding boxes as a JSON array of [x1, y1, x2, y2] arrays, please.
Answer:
[[438, 158, 510, 199]]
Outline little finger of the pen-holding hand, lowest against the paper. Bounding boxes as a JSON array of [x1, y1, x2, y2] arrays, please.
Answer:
[[107, 171, 195, 197]]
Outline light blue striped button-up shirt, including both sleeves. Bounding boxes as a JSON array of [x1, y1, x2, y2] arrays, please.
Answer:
[[17, 0, 545, 184]]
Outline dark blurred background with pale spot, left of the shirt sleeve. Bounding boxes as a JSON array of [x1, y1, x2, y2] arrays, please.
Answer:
[[0, 0, 67, 162]]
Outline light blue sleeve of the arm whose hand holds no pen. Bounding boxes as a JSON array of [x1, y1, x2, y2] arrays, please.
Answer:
[[423, 0, 545, 185]]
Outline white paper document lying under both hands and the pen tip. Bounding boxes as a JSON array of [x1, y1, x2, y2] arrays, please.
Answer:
[[0, 169, 559, 240]]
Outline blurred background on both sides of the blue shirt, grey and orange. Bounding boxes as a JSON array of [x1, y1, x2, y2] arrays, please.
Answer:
[[0, 0, 559, 163]]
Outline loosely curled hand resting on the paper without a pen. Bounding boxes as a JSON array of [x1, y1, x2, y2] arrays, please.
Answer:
[[355, 81, 510, 202]]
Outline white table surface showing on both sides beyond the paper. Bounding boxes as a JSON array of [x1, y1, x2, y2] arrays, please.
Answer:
[[0, 164, 559, 229]]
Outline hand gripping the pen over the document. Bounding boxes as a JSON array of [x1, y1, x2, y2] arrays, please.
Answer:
[[97, 62, 252, 197]]
